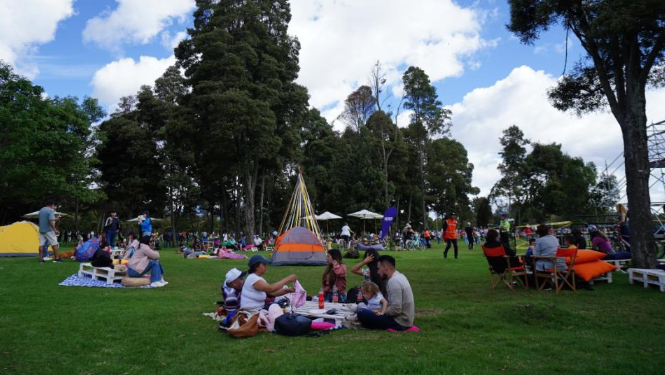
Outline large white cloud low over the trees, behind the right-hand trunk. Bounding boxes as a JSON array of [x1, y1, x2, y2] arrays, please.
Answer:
[[449, 66, 665, 200]]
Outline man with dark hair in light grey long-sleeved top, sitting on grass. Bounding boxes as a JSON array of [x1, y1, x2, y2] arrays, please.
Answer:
[[358, 255, 415, 331]]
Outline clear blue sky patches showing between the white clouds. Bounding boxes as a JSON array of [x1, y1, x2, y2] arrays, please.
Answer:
[[14, 0, 580, 113]]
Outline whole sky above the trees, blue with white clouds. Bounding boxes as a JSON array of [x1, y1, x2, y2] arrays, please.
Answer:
[[0, 0, 665, 198]]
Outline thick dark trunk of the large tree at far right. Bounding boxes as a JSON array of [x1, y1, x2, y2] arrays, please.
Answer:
[[618, 84, 657, 268]]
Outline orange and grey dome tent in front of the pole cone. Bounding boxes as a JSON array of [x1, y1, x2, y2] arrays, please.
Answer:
[[272, 227, 327, 266]]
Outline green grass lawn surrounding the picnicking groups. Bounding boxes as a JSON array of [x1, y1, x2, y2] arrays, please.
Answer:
[[0, 244, 665, 375]]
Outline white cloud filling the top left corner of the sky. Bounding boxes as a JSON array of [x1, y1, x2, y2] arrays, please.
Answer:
[[0, 0, 74, 78]]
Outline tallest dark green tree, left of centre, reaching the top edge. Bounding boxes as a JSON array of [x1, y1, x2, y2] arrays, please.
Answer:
[[175, 0, 307, 238]]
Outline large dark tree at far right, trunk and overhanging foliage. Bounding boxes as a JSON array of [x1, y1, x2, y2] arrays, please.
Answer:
[[508, 0, 665, 268]]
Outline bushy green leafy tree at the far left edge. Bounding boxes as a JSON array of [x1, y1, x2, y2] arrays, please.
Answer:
[[0, 62, 104, 223]]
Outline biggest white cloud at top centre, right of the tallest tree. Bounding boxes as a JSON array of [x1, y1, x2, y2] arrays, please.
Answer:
[[289, 0, 496, 126]]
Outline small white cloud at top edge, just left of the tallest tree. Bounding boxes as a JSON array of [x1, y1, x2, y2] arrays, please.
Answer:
[[83, 0, 196, 52]]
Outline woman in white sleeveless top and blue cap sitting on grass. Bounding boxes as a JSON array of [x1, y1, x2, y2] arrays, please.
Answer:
[[240, 255, 296, 312]]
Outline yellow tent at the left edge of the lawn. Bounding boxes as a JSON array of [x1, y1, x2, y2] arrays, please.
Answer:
[[0, 221, 39, 257]]
